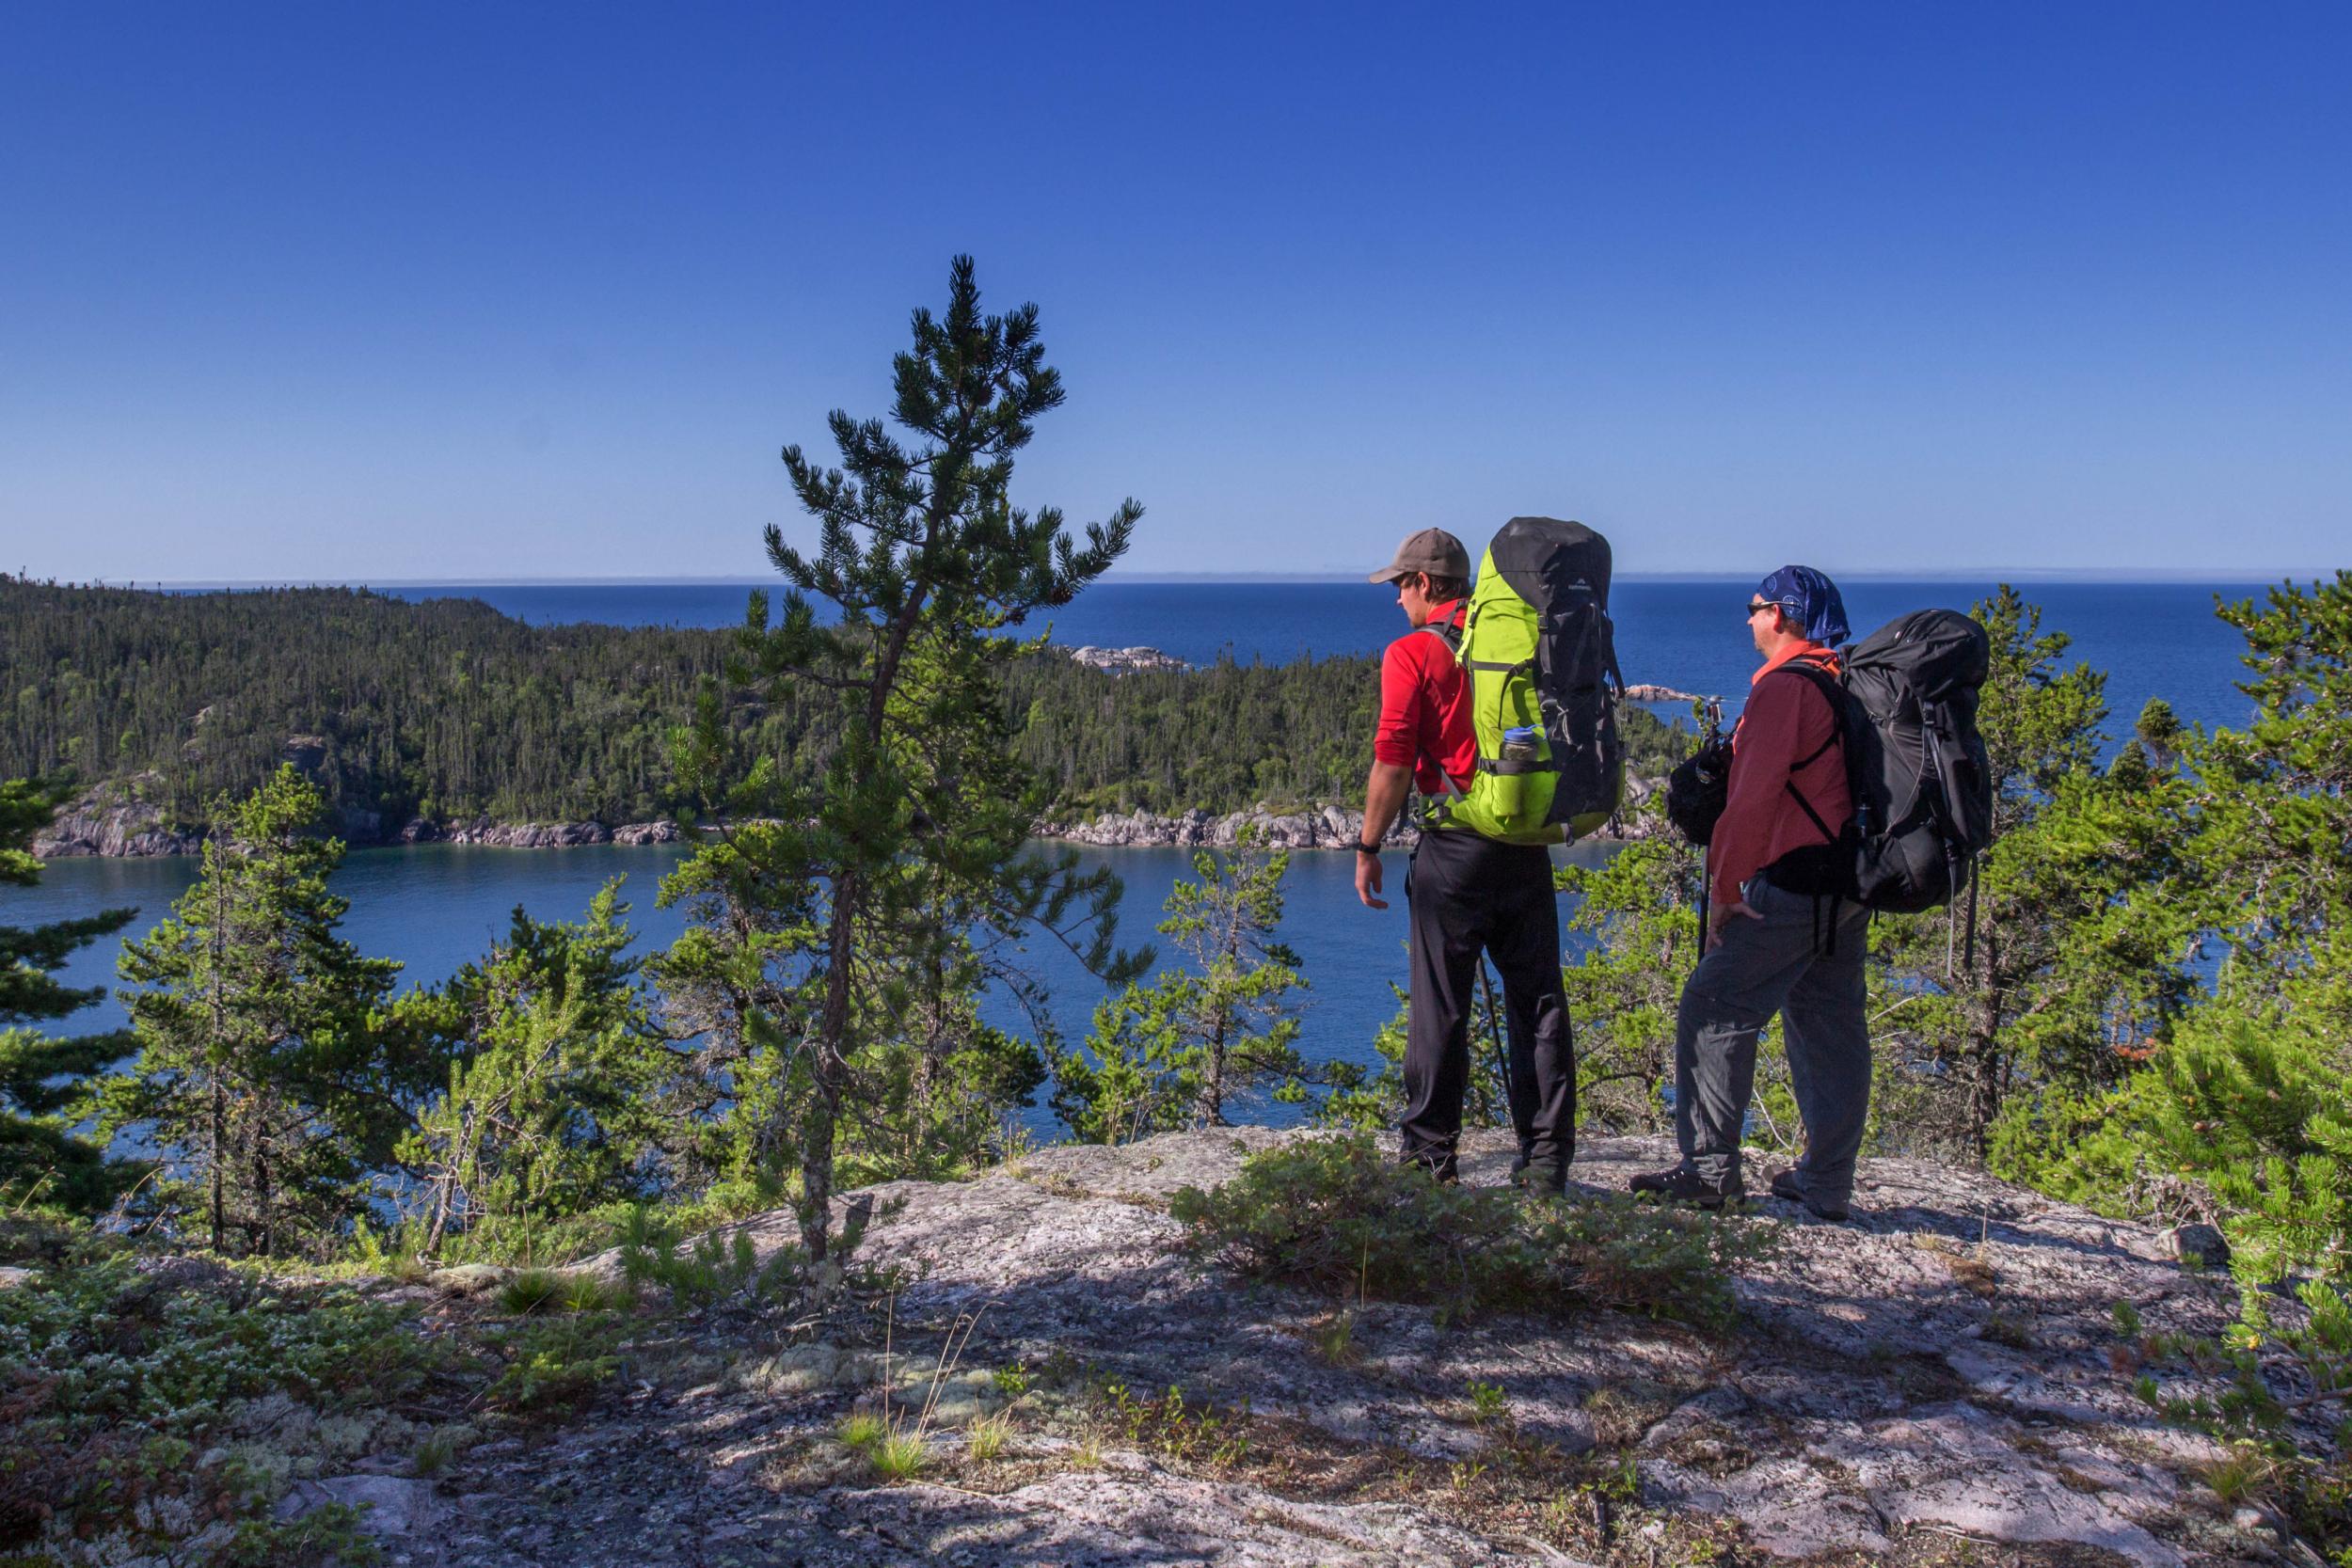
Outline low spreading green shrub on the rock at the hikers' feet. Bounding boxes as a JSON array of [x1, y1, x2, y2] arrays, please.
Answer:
[[1169, 1135, 1772, 1326]]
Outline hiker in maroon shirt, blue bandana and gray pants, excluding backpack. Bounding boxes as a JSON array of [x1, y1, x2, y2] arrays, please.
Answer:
[[1632, 566, 1870, 1220]]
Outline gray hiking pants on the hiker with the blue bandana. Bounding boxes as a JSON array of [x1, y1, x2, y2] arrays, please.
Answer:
[[1675, 877, 1870, 1206]]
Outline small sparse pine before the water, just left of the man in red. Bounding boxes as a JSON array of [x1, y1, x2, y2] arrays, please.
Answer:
[[1054, 844, 1306, 1143]]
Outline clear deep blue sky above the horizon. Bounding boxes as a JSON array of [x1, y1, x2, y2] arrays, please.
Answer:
[[0, 2, 2352, 580]]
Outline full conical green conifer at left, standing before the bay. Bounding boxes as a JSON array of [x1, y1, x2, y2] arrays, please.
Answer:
[[103, 767, 402, 1258]]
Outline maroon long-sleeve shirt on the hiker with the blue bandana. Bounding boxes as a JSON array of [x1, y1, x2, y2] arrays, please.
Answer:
[[1708, 641, 1853, 910]]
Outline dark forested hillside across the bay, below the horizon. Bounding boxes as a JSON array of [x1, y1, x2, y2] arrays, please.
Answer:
[[0, 576, 1673, 832]]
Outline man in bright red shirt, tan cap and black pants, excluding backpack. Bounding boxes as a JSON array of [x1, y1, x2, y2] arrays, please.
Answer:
[[1355, 529, 1576, 1192]]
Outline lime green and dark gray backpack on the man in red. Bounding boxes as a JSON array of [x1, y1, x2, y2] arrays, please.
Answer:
[[1425, 517, 1626, 844]]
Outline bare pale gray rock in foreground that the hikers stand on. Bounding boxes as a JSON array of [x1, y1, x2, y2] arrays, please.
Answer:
[[367, 1129, 2280, 1568]]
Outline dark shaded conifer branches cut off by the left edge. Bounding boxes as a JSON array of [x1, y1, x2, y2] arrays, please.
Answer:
[[0, 778, 139, 1213]]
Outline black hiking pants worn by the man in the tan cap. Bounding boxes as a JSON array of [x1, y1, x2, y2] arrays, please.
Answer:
[[1402, 828, 1576, 1185]]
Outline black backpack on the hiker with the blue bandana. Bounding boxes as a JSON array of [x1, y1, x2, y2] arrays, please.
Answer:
[[1781, 609, 1993, 914]]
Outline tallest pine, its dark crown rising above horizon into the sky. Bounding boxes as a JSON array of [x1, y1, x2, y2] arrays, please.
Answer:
[[682, 256, 1141, 1258]]
